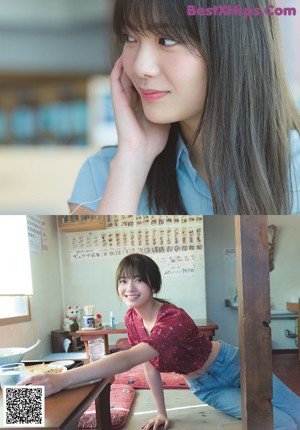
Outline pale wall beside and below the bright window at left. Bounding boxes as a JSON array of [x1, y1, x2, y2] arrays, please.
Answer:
[[0, 217, 63, 359]]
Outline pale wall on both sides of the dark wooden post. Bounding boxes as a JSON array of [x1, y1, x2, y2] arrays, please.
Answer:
[[204, 216, 300, 349]]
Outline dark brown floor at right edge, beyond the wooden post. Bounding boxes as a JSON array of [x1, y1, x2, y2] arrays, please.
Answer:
[[272, 351, 300, 396]]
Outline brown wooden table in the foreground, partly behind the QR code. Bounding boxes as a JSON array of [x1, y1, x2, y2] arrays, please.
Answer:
[[0, 377, 114, 430]]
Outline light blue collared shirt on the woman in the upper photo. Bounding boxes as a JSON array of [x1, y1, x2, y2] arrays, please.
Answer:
[[69, 131, 300, 215]]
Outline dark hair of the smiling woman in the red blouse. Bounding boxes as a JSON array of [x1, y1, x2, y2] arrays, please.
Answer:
[[116, 254, 169, 303]]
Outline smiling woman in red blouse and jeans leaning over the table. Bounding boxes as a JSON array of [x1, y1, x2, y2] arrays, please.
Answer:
[[20, 254, 300, 430]]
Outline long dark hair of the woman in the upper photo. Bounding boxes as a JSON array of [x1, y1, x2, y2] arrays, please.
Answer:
[[113, 0, 300, 214]]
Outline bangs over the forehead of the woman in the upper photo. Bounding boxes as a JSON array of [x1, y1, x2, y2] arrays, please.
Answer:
[[113, 0, 200, 51]]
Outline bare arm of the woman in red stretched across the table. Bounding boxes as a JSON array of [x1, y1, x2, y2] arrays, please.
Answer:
[[19, 343, 159, 396]]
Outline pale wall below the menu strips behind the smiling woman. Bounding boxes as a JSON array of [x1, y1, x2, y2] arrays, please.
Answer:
[[59, 218, 206, 342]]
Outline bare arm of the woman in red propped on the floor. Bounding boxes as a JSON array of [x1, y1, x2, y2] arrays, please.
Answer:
[[142, 362, 169, 430]]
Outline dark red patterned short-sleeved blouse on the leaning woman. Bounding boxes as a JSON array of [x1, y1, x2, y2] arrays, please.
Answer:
[[125, 303, 212, 374]]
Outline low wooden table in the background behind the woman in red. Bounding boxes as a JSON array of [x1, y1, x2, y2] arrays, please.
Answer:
[[76, 319, 218, 357]]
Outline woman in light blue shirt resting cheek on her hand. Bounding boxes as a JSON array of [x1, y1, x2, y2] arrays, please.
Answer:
[[69, 0, 300, 214]]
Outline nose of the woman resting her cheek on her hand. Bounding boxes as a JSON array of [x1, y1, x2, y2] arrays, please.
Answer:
[[133, 46, 160, 78]]
